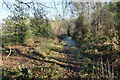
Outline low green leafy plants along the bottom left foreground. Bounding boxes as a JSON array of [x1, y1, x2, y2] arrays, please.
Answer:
[[2, 65, 64, 80]]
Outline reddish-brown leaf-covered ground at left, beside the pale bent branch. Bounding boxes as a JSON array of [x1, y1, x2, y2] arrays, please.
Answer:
[[2, 45, 42, 68]]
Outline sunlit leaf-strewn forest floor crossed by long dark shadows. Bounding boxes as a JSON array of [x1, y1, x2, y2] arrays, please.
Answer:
[[2, 39, 120, 80]]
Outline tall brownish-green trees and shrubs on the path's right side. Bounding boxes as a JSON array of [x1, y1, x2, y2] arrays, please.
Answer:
[[73, 2, 119, 44]]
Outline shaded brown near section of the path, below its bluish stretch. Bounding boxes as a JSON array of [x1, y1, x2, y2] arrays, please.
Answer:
[[61, 47, 82, 78]]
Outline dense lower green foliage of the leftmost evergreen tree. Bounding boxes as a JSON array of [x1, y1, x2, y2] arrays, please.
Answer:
[[3, 18, 27, 43]]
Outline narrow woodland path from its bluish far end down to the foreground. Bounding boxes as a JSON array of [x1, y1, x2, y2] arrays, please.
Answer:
[[60, 37, 82, 79]]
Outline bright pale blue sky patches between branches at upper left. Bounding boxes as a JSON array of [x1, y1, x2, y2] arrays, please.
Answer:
[[0, 0, 66, 23]]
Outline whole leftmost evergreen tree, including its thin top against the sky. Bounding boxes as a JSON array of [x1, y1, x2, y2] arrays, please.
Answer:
[[3, 3, 28, 44]]
